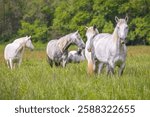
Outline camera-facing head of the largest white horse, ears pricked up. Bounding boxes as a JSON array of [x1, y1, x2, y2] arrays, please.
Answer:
[[116, 18, 128, 44]]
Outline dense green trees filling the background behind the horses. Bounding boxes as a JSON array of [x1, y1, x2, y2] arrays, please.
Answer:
[[0, 0, 150, 44]]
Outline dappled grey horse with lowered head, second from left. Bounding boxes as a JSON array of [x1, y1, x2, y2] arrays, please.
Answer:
[[46, 31, 85, 67]]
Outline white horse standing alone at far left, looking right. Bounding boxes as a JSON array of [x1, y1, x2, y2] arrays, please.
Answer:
[[4, 36, 34, 69]]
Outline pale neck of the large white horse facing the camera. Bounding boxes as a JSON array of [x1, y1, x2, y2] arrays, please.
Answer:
[[112, 27, 123, 53]]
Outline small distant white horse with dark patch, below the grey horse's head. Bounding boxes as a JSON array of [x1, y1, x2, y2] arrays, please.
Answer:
[[67, 49, 85, 63]]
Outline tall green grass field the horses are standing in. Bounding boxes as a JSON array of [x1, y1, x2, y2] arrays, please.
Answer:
[[0, 46, 150, 100]]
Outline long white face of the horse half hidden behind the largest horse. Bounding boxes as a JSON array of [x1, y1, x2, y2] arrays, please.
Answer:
[[86, 26, 99, 52]]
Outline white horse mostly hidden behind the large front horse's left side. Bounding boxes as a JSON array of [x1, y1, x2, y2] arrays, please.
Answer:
[[85, 26, 99, 74]]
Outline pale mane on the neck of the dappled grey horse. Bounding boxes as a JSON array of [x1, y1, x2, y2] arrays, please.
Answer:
[[57, 33, 72, 52]]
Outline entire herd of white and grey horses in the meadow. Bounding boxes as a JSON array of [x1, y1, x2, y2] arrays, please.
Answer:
[[4, 16, 128, 76]]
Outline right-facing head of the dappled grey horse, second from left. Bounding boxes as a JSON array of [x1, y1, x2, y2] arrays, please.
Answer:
[[72, 31, 85, 49]]
